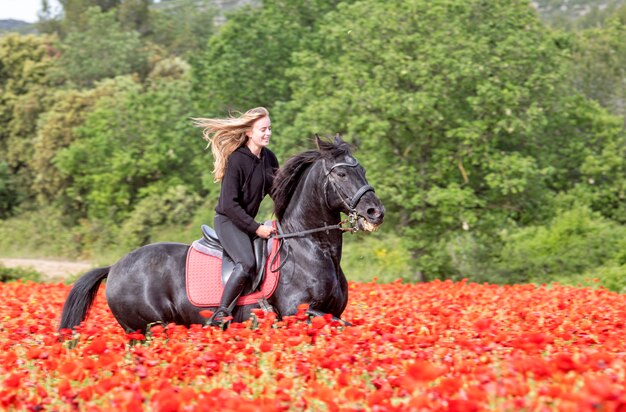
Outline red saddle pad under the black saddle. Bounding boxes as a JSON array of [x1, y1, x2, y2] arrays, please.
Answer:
[[185, 239, 280, 307]]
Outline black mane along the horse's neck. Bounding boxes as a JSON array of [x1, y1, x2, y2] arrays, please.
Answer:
[[272, 137, 351, 220]]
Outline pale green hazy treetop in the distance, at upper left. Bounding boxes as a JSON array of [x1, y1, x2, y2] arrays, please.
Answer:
[[57, 7, 148, 86]]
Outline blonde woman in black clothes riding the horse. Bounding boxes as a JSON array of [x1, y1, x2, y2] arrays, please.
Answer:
[[193, 107, 278, 326]]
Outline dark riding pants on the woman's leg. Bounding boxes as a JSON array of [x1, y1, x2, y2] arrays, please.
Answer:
[[214, 214, 256, 307]]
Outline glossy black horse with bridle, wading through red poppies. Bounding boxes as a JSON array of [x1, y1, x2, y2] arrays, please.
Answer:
[[59, 136, 384, 332]]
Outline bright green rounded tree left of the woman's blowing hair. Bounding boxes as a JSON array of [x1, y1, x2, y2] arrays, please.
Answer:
[[54, 72, 204, 223]]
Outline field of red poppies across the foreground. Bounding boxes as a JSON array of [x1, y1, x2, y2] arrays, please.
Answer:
[[0, 281, 626, 411]]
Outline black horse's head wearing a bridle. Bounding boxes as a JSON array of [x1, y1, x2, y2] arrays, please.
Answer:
[[315, 135, 385, 232]]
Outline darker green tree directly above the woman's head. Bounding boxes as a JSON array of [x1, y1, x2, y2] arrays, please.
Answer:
[[191, 0, 354, 115]]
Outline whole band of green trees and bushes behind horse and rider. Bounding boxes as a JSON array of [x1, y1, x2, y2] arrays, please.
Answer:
[[0, 0, 626, 291]]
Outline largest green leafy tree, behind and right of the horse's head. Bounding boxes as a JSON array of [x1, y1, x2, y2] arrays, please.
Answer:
[[276, 0, 616, 278]]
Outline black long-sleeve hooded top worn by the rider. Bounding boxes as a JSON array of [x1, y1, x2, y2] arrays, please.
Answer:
[[215, 146, 278, 235]]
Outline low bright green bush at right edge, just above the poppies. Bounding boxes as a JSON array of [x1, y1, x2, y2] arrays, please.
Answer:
[[499, 206, 626, 287]]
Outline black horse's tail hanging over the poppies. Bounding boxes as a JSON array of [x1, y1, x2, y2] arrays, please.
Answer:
[[59, 266, 111, 330]]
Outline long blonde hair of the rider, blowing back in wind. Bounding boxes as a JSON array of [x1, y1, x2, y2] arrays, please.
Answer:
[[192, 107, 270, 182]]
